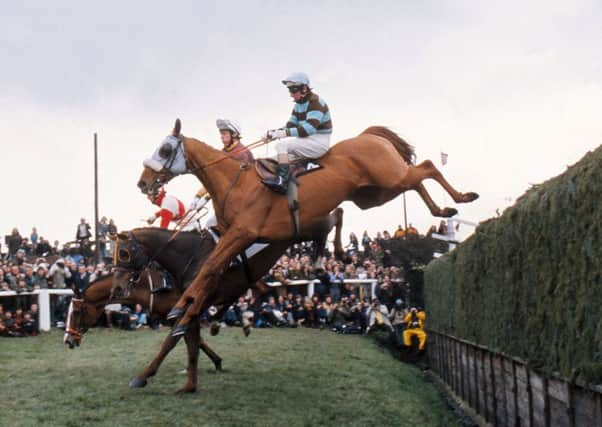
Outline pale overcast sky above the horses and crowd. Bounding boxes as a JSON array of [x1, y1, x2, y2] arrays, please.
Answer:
[[0, 0, 602, 246]]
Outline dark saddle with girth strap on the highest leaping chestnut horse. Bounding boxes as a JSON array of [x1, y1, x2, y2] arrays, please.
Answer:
[[255, 159, 323, 241]]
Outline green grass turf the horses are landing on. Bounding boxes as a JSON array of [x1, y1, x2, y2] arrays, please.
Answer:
[[0, 328, 457, 427]]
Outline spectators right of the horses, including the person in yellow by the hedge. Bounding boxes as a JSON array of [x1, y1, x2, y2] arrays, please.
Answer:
[[217, 225, 442, 350]]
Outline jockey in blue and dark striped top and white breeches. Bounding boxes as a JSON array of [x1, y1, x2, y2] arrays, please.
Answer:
[[263, 73, 332, 193]]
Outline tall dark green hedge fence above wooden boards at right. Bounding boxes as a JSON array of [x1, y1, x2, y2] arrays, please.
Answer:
[[425, 146, 602, 384]]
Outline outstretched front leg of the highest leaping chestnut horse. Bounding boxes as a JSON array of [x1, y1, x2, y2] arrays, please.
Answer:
[[168, 226, 256, 335]]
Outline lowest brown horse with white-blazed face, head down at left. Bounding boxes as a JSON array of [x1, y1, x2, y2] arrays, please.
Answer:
[[63, 269, 222, 391]]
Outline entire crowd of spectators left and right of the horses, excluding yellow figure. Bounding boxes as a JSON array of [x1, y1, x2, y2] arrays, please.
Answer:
[[0, 218, 434, 352]]
